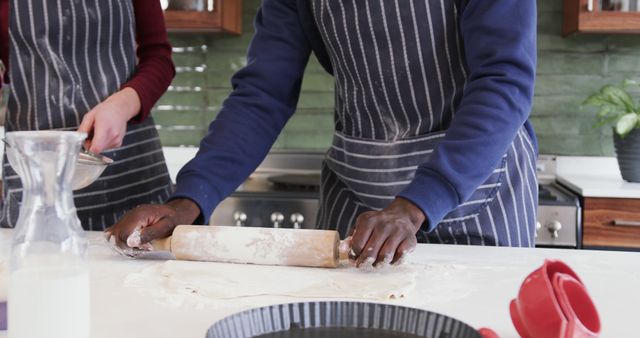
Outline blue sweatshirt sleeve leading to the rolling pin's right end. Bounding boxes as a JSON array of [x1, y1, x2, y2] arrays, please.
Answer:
[[398, 0, 536, 231]]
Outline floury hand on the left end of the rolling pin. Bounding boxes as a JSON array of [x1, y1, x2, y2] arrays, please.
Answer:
[[105, 199, 200, 256]]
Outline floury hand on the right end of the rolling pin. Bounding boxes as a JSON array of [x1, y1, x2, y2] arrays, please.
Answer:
[[349, 197, 426, 266]]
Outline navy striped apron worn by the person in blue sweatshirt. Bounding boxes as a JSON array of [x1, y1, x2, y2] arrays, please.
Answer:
[[312, 0, 538, 246]]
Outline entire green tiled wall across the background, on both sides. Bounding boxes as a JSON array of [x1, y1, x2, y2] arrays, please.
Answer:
[[154, 0, 640, 155]]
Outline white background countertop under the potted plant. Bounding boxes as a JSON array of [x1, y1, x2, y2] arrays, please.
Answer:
[[557, 156, 640, 198]]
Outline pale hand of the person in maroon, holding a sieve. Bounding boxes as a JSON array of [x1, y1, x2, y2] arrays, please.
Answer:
[[78, 87, 140, 154]]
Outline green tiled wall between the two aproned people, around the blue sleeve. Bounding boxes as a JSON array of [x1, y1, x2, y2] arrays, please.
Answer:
[[153, 0, 334, 149]]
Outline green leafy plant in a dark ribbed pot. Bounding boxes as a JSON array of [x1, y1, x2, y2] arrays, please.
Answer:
[[584, 80, 640, 182]]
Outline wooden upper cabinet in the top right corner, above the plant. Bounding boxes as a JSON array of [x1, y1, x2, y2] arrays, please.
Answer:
[[563, 0, 640, 36]]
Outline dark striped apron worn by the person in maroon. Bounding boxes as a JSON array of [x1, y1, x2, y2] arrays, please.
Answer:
[[0, 0, 170, 230]]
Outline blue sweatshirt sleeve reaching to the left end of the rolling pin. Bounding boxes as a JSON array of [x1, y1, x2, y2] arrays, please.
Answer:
[[171, 0, 311, 222]]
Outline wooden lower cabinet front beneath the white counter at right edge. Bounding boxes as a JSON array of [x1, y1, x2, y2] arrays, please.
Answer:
[[582, 197, 640, 249]]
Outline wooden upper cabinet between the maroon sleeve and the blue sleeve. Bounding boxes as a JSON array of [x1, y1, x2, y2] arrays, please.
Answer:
[[161, 0, 242, 34]]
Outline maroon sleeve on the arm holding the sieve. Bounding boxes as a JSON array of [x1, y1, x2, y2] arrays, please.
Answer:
[[122, 0, 175, 121]]
